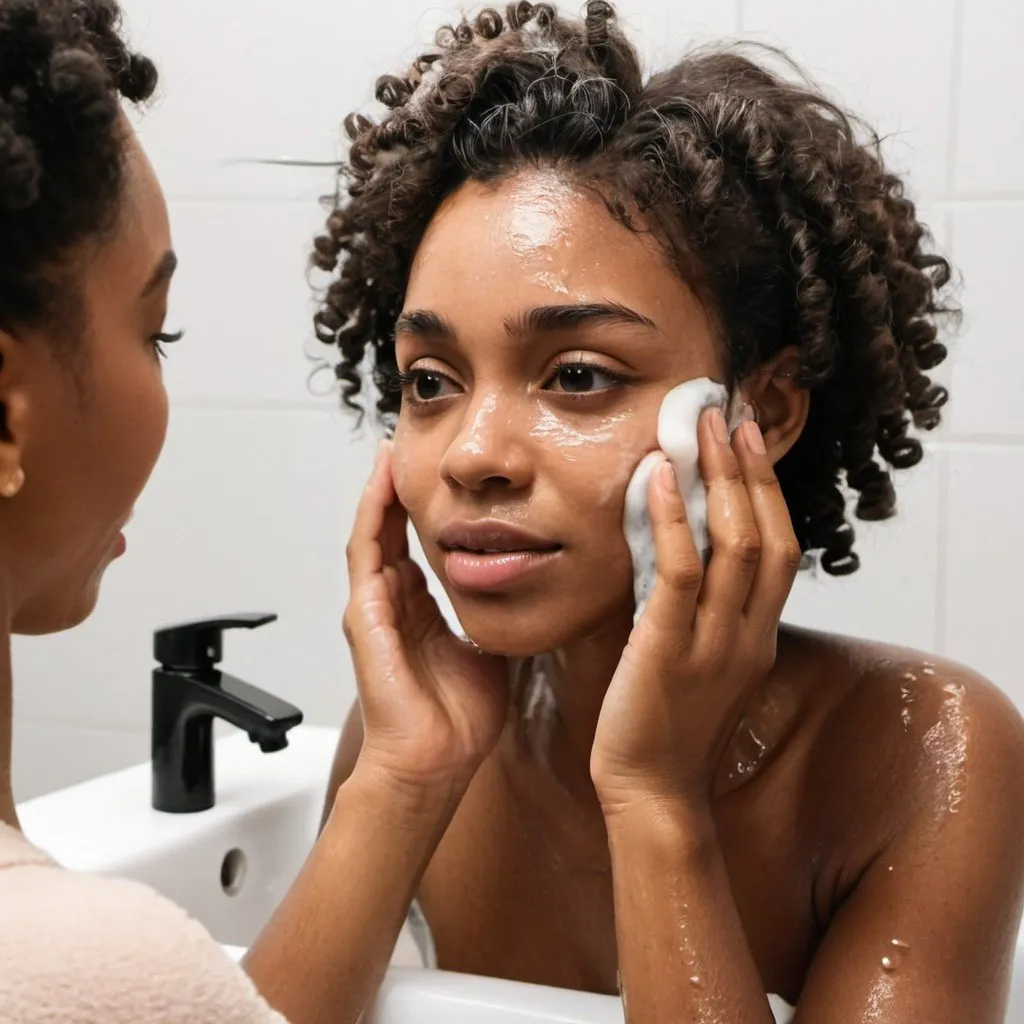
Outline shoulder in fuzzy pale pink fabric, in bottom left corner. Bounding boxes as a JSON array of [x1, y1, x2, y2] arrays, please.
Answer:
[[0, 864, 285, 1024]]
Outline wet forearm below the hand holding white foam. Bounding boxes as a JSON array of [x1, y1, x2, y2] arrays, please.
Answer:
[[608, 804, 773, 1024]]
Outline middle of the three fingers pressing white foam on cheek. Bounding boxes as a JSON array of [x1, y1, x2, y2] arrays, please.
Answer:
[[698, 409, 761, 618]]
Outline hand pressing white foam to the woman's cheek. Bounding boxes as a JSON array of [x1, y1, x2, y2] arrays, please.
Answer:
[[591, 410, 801, 812]]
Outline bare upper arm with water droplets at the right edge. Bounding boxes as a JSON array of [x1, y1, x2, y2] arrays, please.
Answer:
[[797, 678, 1024, 1024]]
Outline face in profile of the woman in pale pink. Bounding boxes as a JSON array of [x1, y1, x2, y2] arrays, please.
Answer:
[[0, 123, 174, 633]]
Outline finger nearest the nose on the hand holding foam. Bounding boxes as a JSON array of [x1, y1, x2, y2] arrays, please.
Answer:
[[641, 459, 703, 643]]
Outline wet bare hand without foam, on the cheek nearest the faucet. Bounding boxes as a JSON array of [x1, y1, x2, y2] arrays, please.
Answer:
[[344, 442, 508, 786]]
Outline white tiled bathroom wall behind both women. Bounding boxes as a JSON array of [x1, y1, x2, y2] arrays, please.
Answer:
[[9, 0, 1024, 796]]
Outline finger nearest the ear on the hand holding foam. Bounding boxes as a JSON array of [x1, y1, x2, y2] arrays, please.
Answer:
[[733, 423, 801, 626]]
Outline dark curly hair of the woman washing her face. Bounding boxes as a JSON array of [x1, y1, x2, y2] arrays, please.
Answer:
[[313, 0, 956, 575]]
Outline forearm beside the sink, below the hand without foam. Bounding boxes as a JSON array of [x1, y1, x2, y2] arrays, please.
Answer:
[[245, 767, 459, 1024]]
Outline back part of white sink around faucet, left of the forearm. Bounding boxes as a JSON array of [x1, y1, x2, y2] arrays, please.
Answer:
[[18, 727, 338, 946]]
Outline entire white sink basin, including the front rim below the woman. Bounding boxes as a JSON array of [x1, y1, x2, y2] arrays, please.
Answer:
[[18, 726, 1024, 1024]]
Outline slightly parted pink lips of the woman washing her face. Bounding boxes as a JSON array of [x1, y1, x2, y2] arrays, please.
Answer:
[[437, 520, 562, 591]]
